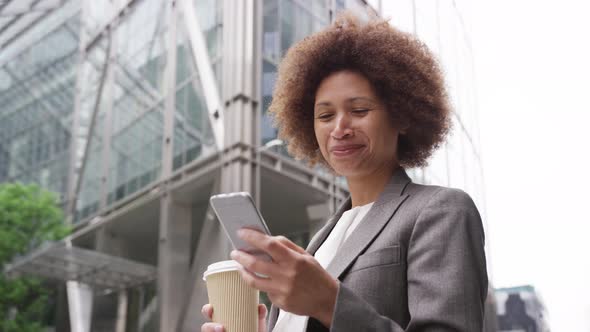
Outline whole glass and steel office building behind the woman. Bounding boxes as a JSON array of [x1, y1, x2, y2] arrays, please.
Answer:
[[0, 0, 485, 331]]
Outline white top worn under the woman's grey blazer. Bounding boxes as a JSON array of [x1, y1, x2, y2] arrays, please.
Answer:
[[272, 202, 374, 332]]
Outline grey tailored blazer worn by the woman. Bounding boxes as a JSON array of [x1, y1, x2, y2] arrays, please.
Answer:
[[268, 168, 488, 332]]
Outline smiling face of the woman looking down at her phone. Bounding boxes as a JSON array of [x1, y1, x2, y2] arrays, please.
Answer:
[[314, 70, 398, 179]]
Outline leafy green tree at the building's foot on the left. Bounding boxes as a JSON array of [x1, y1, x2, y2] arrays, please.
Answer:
[[0, 183, 70, 332]]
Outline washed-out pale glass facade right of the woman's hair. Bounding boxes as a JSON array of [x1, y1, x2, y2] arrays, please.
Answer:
[[383, 0, 485, 215]]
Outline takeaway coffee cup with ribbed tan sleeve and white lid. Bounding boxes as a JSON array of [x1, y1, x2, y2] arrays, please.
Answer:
[[203, 260, 259, 332]]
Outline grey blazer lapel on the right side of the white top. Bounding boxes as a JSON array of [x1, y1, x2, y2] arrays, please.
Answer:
[[318, 168, 410, 278]]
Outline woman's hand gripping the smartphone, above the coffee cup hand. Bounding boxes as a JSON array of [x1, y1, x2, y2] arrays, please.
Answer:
[[231, 229, 339, 327]]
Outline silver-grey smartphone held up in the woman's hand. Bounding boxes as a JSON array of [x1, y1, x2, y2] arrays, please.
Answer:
[[209, 192, 272, 261]]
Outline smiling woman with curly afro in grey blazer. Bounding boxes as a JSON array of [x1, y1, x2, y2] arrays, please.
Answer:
[[202, 13, 487, 332]]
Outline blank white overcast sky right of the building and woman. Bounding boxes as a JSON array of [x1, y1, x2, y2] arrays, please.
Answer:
[[383, 0, 590, 332]]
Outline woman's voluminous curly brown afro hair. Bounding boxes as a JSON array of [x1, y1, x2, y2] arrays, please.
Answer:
[[269, 11, 451, 168]]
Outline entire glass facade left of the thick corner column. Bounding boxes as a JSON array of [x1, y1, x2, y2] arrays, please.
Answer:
[[0, 0, 223, 221]]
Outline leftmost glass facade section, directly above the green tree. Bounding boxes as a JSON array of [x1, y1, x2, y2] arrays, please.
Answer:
[[0, 6, 80, 202]]
